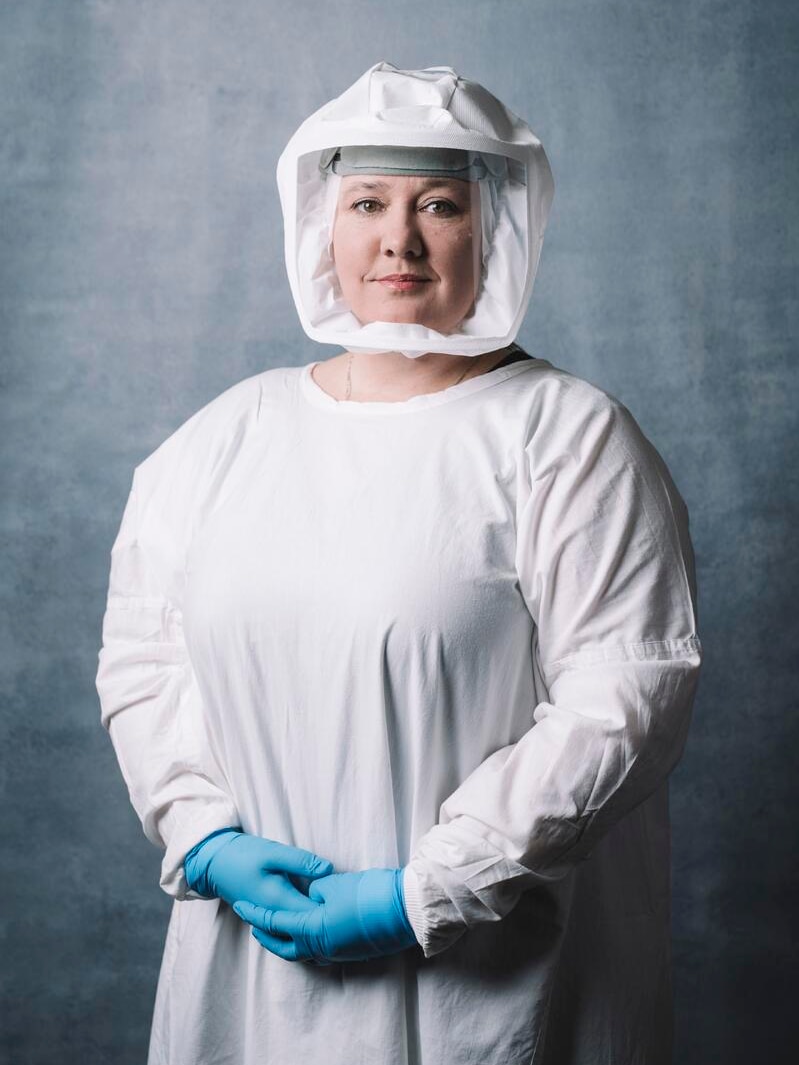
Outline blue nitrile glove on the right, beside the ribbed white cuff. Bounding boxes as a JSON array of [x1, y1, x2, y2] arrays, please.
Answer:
[[233, 869, 417, 964]]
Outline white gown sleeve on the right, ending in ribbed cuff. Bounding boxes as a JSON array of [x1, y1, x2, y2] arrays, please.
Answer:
[[404, 390, 701, 956]]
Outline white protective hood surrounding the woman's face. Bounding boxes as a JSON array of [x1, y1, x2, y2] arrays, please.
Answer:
[[277, 63, 554, 358]]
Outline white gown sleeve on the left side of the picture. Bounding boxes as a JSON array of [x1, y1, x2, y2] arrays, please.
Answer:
[[96, 471, 240, 899]]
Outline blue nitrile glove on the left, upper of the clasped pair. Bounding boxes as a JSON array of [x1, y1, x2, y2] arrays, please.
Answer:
[[183, 829, 333, 912]]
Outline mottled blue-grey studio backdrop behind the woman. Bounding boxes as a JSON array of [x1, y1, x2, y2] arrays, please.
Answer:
[[0, 0, 799, 1065]]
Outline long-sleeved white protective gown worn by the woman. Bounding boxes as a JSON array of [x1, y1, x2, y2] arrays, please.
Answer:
[[97, 359, 701, 1065]]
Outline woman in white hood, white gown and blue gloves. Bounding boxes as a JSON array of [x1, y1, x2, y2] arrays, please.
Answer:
[[98, 63, 701, 1065]]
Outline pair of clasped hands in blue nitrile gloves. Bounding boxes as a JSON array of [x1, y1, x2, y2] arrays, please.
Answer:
[[183, 829, 417, 965]]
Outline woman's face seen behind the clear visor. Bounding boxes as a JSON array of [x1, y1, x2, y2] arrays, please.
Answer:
[[332, 175, 482, 333]]
